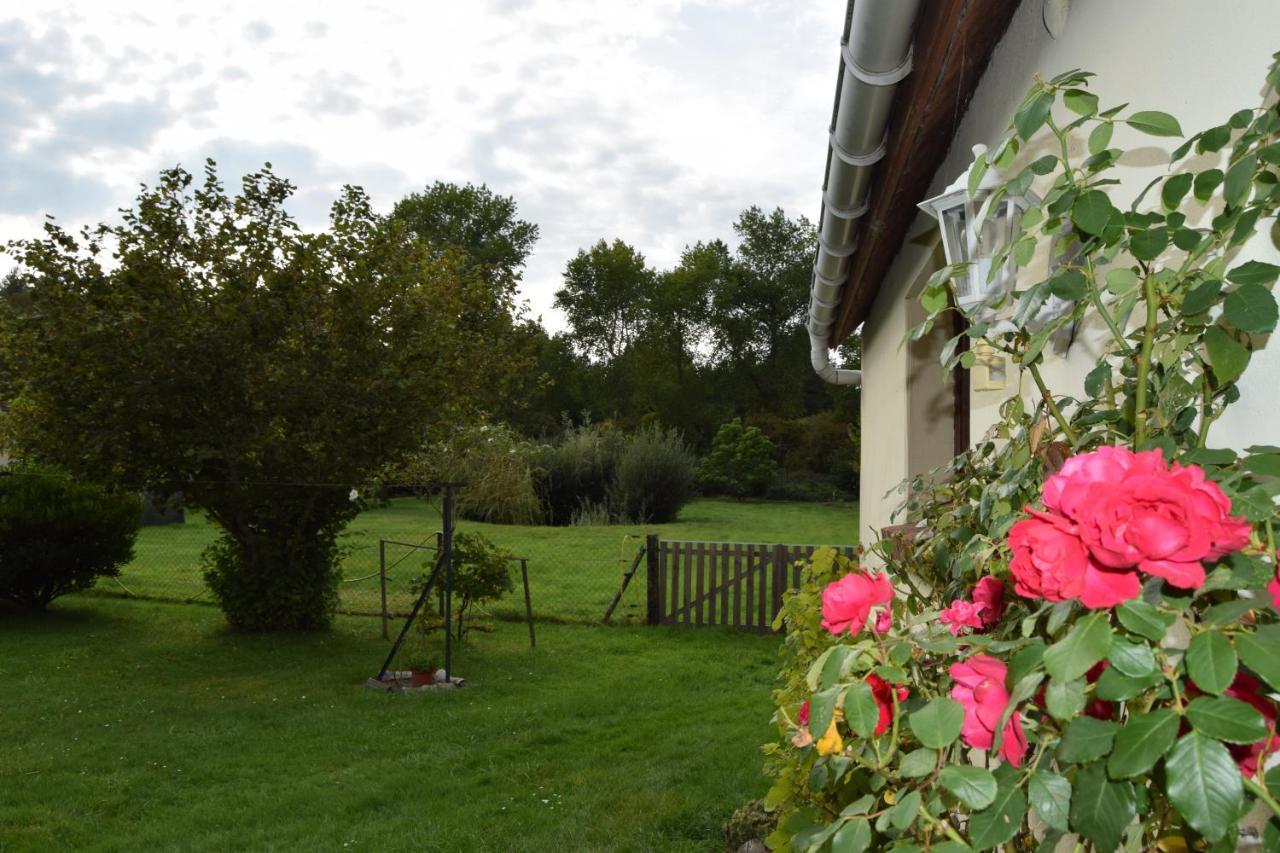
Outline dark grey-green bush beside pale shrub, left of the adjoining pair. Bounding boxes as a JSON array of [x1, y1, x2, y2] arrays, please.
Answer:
[[534, 424, 626, 526]]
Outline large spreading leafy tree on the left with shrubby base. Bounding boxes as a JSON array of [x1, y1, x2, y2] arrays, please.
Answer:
[[3, 161, 507, 629]]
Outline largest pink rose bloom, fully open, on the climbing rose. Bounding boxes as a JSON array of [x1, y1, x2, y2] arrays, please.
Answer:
[[1043, 447, 1249, 589]]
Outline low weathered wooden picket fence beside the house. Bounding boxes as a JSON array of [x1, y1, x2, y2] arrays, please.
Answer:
[[645, 535, 856, 633]]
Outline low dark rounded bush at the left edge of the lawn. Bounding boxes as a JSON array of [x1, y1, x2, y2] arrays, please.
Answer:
[[0, 467, 142, 607]]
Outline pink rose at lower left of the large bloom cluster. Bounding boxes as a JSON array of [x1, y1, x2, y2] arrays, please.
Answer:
[[1009, 507, 1142, 608]]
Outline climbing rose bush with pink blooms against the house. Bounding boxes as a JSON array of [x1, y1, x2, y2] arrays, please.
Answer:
[[765, 54, 1280, 853]]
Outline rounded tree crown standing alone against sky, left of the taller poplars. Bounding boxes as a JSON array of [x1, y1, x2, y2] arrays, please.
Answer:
[[556, 240, 657, 360]]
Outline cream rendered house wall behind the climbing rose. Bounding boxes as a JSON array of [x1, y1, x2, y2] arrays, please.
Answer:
[[861, 0, 1280, 545]]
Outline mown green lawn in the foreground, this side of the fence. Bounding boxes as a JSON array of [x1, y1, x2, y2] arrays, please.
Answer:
[[0, 594, 783, 853]]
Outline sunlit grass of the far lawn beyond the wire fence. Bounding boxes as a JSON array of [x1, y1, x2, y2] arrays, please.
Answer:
[[110, 498, 858, 620]]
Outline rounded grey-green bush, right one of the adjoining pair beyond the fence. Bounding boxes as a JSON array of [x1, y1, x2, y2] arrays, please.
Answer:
[[609, 427, 695, 524]]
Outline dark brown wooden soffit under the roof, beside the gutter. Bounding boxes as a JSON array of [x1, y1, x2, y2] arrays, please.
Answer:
[[831, 0, 1020, 347]]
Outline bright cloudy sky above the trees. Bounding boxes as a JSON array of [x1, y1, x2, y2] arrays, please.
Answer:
[[0, 0, 846, 329]]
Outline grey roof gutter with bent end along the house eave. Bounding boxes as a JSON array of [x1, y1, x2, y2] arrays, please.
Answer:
[[808, 0, 919, 386]]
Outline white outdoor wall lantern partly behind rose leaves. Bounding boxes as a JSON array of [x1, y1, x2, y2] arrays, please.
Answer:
[[919, 145, 1038, 309]]
